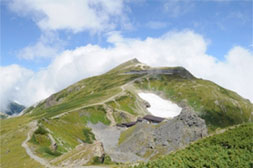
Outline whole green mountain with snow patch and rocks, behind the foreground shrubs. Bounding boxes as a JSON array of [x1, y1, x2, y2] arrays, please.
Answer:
[[0, 59, 253, 168]]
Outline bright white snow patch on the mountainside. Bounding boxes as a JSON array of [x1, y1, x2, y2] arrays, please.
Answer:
[[138, 93, 182, 118]]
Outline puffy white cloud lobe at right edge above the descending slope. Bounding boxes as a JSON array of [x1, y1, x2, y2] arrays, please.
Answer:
[[211, 46, 253, 102]]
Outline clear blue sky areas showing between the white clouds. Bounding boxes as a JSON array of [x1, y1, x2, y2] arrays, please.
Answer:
[[1, 1, 252, 71]]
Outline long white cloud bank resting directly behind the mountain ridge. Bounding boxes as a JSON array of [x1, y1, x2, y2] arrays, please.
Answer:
[[0, 31, 253, 111]]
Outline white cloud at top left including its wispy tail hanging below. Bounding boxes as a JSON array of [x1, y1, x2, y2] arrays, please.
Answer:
[[5, 0, 130, 60]]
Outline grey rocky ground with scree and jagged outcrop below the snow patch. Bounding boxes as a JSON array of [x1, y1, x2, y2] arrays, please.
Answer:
[[89, 107, 208, 163]]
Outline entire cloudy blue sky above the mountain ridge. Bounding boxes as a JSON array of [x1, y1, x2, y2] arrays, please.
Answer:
[[0, 0, 253, 110]]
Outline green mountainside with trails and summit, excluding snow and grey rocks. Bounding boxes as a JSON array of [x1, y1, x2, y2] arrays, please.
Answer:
[[0, 59, 253, 168]]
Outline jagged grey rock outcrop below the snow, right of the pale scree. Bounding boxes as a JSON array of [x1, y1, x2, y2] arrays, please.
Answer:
[[118, 107, 207, 162]]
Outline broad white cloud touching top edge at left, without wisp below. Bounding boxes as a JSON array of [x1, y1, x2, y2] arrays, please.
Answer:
[[8, 0, 126, 33]]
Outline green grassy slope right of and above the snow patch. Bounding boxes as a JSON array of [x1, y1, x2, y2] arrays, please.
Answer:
[[135, 75, 253, 129]]
